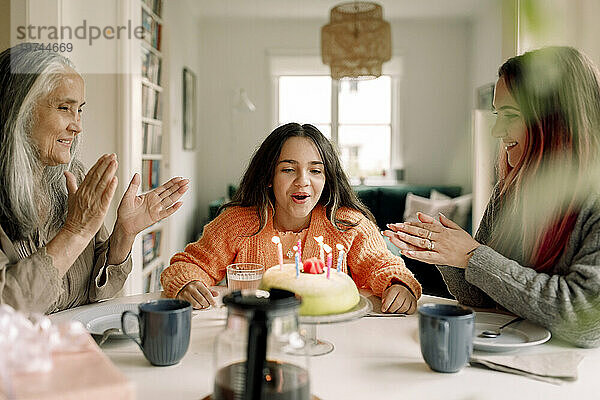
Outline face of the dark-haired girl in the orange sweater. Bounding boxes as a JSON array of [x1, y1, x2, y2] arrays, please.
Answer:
[[273, 137, 325, 231]]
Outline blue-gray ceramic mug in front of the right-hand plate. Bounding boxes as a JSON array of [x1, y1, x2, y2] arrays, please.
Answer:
[[419, 304, 475, 372]]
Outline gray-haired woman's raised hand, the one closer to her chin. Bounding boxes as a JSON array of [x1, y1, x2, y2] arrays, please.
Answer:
[[63, 154, 118, 244]]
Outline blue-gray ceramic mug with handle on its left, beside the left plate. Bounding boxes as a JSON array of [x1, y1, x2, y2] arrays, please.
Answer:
[[121, 299, 192, 367]]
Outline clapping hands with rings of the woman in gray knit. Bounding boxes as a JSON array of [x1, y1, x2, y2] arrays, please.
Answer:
[[383, 213, 480, 268]]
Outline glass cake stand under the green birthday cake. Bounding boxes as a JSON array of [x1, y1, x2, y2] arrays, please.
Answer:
[[299, 294, 373, 356]]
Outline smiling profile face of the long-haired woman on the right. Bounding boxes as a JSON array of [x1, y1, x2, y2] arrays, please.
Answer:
[[492, 78, 527, 168]]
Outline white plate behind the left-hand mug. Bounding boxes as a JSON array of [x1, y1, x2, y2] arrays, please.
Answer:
[[73, 303, 139, 339]]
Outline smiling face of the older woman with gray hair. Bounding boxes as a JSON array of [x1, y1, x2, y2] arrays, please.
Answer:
[[31, 70, 85, 166]]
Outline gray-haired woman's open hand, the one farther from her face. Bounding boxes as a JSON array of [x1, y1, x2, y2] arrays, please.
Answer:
[[115, 174, 190, 236]]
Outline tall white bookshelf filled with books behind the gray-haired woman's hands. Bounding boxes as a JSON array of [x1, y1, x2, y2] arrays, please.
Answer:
[[118, 0, 170, 294]]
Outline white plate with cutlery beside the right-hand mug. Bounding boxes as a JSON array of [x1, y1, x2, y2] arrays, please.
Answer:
[[473, 312, 551, 352]]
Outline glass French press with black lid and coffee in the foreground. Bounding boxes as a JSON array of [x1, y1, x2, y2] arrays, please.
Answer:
[[213, 289, 310, 400]]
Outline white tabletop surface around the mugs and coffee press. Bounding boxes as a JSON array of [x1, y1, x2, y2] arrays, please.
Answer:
[[51, 293, 600, 400]]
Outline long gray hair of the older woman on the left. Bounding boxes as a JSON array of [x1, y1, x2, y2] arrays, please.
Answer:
[[0, 43, 84, 244]]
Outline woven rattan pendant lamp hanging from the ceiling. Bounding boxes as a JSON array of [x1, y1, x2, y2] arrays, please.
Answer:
[[321, 1, 392, 79]]
